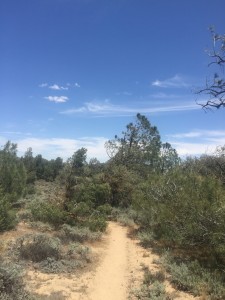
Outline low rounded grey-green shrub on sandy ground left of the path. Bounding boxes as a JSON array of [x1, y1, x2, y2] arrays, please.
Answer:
[[17, 234, 61, 262]]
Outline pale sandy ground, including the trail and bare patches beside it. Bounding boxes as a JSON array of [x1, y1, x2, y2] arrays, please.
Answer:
[[24, 222, 199, 300]]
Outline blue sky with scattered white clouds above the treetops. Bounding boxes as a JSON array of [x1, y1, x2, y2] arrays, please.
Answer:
[[0, 0, 225, 161]]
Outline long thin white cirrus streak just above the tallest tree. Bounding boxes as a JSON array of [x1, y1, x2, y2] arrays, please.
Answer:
[[60, 101, 199, 117]]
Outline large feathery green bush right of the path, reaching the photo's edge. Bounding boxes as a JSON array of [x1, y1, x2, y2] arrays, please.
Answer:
[[133, 170, 225, 263]]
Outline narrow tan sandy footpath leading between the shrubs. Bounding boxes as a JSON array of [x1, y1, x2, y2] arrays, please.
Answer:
[[88, 223, 129, 300]]
